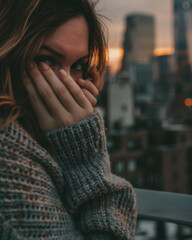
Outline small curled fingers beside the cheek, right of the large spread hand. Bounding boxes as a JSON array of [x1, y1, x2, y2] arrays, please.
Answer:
[[77, 66, 99, 107]]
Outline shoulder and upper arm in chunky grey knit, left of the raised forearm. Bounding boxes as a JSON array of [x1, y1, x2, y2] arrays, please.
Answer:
[[0, 122, 84, 240]]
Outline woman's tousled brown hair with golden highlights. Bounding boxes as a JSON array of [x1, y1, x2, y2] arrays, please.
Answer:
[[0, 0, 106, 142]]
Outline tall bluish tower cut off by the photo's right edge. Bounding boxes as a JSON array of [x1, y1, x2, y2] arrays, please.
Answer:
[[174, 0, 192, 83]]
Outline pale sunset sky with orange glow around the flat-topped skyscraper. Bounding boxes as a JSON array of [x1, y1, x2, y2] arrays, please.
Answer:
[[97, 0, 174, 72]]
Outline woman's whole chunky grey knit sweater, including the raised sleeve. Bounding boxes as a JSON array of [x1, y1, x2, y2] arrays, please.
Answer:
[[0, 109, 137, 240]]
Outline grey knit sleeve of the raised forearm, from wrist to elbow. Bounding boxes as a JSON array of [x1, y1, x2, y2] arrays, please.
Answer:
[[45, 109, 137, 240]]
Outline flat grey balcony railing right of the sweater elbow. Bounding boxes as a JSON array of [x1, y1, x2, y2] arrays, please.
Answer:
[[135, 188, 192, 226]]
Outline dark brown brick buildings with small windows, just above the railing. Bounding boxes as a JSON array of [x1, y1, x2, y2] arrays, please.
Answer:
[[108, 125, 192, 194]]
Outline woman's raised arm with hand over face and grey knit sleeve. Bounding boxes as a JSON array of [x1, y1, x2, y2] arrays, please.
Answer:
[[23, 61, 136, 240]]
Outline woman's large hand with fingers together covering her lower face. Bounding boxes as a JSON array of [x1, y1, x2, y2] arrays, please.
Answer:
[[22, 63, 96, 132]]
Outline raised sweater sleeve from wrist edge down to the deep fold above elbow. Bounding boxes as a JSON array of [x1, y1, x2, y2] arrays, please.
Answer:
[[42, 109, 111, 213]]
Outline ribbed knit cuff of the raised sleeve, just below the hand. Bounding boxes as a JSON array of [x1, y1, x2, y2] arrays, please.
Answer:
[[45, 108, 106, 166]]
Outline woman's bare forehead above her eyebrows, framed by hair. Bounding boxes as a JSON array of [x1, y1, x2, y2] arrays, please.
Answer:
[[44, 16, 89, 54]]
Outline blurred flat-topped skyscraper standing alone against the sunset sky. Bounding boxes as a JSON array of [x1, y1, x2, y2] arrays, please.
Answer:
[[121, 14, 155, 71]]
